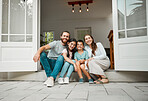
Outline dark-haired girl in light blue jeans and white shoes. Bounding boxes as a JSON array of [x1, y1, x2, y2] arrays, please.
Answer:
[[58, 38, 77, 84]]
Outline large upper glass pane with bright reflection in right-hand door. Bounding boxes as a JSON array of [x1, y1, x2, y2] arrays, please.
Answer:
[[126, 0, 146, 29]]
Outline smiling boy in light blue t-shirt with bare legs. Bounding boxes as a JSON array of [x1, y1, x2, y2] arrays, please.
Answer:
[[74, 40, 93, 84]]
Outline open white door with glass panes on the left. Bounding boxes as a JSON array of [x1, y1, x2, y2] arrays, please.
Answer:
[[0, 0, 38, 72]]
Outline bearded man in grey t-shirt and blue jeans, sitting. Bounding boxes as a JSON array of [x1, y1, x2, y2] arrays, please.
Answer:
[[33, 31, 70, 87]]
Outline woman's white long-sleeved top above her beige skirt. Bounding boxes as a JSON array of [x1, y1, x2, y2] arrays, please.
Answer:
[[85, 42, 109, 60]]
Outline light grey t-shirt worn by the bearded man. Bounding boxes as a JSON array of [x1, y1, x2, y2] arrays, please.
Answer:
[[47, 40, 66, 59]]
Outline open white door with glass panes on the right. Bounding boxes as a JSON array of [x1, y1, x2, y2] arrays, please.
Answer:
[[112, 0, 148, 71]]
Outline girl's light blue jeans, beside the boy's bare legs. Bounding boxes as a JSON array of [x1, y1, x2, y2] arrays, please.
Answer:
[[60, 60, 76, 78]]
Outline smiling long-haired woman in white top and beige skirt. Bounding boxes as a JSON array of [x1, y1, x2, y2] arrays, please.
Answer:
[[84, 34, 110, 84]]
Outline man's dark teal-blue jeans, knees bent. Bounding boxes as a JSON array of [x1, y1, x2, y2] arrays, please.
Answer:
[[40, 52, 64, 79]]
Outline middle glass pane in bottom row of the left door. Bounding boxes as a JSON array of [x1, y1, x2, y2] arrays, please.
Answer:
[[10, 35, 25, 42]]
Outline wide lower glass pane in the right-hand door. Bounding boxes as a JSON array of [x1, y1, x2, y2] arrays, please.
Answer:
[[127, 29, 147, 37]]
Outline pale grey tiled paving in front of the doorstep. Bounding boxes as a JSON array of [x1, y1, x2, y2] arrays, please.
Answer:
[[0, 81, 148, 101]]
